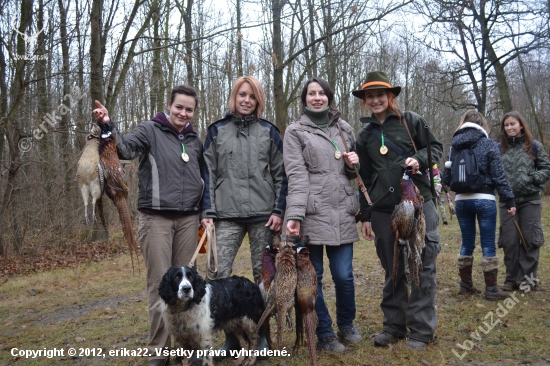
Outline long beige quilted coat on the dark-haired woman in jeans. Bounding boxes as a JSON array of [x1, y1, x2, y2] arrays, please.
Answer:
[[283, 112, 359, 245]]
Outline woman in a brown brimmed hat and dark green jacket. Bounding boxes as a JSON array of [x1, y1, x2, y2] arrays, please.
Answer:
[[353, 71, 443, 349]]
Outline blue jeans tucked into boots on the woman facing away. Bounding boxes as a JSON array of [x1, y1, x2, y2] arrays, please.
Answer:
[[455, 199, 497, 257]]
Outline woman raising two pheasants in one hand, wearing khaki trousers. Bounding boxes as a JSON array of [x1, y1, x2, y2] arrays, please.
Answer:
[[93, 85, 204, 366]]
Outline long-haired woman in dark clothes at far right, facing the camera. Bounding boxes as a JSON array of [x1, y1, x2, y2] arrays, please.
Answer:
[[499, 111, 550, 291]]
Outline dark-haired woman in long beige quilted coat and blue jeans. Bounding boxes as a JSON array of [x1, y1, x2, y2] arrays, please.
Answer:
[[283, 78, 361, 353]]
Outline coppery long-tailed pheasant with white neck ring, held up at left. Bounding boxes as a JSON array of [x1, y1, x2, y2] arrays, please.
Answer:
[[97, 118, 139, 269]]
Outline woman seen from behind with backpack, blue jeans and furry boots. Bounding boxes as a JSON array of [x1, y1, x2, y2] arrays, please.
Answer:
[[443, 110, 516, 300]]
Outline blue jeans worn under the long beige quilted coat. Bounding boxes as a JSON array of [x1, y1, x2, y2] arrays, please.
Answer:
[[307, 244, 355, 339]]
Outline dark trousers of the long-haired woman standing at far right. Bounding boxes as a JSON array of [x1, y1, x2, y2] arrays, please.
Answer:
[[498, 200, 544, 286]]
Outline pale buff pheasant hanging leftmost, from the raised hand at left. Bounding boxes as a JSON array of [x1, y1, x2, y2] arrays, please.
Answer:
[[76, 125, 107, 232]]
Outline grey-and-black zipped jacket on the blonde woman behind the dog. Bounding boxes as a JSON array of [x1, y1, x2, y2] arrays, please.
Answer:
[[202, 114, 287, 219]]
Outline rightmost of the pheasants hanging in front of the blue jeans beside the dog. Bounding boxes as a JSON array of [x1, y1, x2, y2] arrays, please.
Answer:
[[294, 247, 317, 366]]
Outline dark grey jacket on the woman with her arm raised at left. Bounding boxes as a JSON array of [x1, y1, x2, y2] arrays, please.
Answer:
[[113, 113, 204, 213]]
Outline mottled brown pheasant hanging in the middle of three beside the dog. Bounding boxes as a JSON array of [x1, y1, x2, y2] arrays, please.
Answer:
[[256, 245, 296, 347]]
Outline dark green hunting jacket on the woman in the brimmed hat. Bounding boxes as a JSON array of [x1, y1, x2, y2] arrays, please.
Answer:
[[357, 112, 443, 221]]
